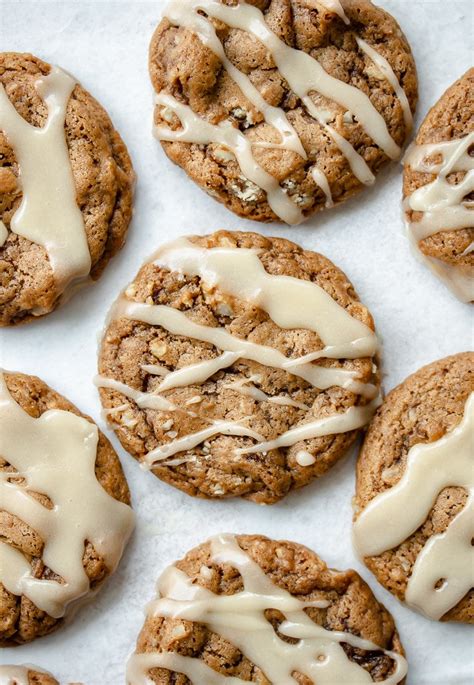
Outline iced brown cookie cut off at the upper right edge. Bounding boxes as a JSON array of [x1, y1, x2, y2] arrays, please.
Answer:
[[403, 69, 474, 302]]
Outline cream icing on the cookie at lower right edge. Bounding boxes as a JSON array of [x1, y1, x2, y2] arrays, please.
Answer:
[[354, 393, 474, 619]]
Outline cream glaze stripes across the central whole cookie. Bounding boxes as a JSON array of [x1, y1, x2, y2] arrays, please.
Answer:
[[96, 238, 378, 468]]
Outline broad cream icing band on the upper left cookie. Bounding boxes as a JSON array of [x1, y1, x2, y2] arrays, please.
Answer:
[[0, 67, 91, 292]]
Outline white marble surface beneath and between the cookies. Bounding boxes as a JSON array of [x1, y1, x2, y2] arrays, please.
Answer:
[[0, 0, 474, 685]]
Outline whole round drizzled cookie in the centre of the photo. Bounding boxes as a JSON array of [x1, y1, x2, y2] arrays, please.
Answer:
[[97, 231, 378, 504]]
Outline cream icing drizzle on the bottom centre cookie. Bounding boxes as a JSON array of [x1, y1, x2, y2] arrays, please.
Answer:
[[127, 535, 407, 685]]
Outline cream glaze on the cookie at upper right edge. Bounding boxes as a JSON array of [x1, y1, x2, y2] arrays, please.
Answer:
[[404, 132, 474, 302]]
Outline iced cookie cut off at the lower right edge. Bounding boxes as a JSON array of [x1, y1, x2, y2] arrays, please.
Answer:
[[354, 352, 474, 623]]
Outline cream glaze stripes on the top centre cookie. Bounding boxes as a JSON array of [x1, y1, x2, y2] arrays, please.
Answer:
[[154, 0, 412, 224]]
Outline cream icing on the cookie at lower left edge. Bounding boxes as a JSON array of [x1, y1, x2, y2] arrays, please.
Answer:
[[0, 373, 133, 618]]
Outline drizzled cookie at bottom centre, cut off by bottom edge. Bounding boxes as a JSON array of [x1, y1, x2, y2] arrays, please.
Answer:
[[127, 535, 407, 685]]
